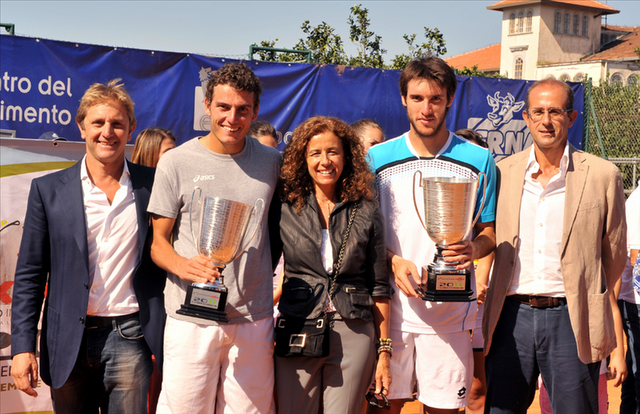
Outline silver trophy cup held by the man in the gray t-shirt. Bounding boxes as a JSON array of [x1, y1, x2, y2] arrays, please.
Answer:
[[177, 187, 264, 322]]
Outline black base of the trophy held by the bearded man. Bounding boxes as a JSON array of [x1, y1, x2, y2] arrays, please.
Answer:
[[421, 263, 476, 302]]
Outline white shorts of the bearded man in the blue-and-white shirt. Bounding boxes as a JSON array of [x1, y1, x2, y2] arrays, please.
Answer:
[[388, 329, 473, 409]]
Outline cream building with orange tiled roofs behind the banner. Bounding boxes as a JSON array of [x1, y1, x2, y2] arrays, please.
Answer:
[[447, 0, 640, 84]]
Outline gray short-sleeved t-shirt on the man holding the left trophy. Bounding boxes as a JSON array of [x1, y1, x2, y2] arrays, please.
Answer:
[[148, 137, 282, 325]]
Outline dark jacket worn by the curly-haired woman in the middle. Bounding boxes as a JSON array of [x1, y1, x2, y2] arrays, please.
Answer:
[[271, 196, 390, 321]]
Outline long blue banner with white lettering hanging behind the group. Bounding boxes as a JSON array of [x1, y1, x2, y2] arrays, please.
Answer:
[[0, 35, 584, 158]]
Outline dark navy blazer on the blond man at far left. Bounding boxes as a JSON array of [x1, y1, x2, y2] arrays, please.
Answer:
[[11, 161, 166, 388]]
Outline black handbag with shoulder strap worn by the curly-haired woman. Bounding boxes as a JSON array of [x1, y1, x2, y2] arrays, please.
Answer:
[[275, 203, 358, 358]]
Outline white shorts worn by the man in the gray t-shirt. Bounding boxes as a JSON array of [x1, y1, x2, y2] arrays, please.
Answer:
[[157, 316, 275, 414]]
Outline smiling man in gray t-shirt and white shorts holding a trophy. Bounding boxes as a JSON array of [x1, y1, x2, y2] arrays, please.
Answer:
[[149, 63, 281, 413]]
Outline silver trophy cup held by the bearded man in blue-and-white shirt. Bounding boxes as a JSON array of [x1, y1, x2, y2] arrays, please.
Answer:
[[413, 171, 487, 302]]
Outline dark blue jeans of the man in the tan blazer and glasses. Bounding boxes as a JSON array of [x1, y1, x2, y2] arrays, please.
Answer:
[[485, 297, 600, 414]]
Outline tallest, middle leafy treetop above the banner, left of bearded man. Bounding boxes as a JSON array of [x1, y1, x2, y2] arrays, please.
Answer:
[[347, 4, 387, 69]]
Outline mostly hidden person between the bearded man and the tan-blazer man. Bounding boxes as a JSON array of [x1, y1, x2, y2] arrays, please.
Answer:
[[456, 129, 493, 414]]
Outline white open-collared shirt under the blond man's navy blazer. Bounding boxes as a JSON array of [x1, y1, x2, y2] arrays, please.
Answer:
[[81, 156, 140, 316]]
